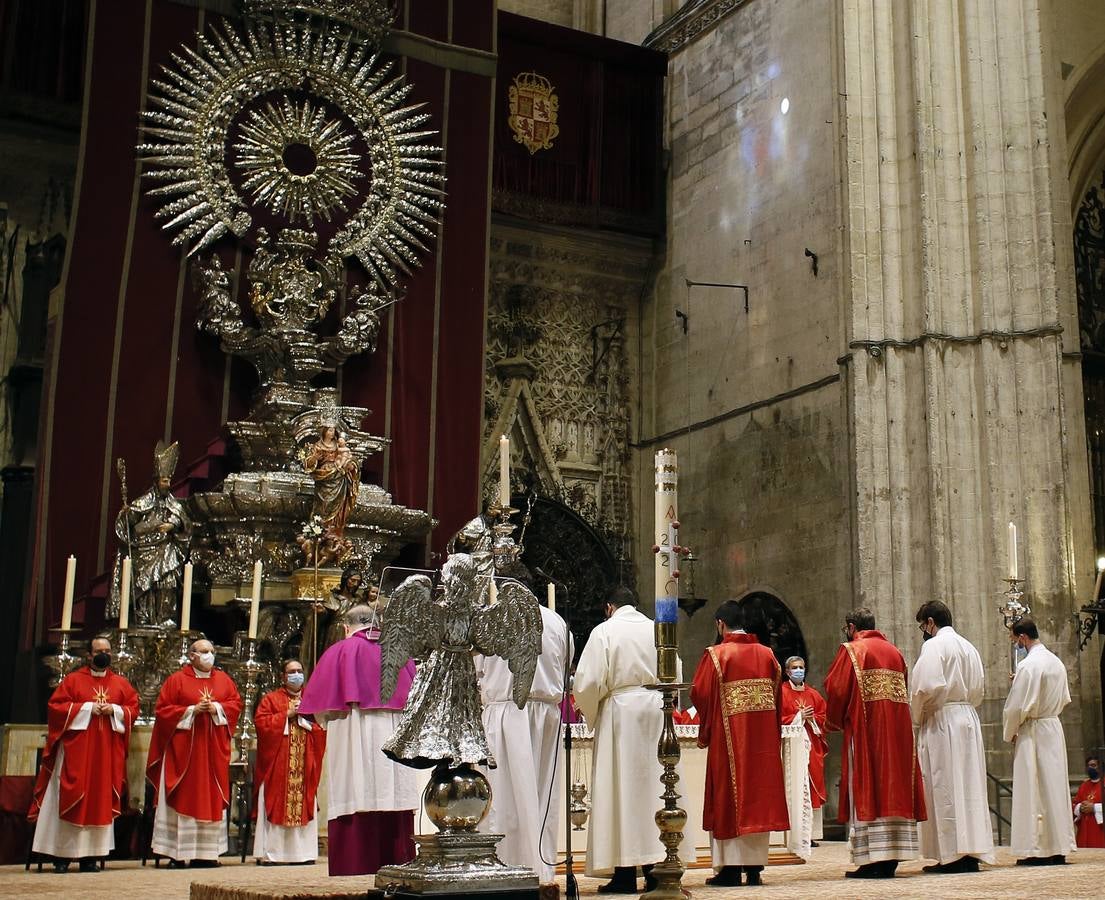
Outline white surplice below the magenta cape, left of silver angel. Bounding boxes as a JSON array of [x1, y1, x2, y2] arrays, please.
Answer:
[[317, 707, 423, 819]]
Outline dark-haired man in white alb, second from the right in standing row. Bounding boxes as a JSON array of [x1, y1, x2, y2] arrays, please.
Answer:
[[909, 600, 993, 873]]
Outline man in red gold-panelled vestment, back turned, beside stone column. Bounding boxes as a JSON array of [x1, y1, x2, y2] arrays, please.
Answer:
[[824, 607, 925, 878]]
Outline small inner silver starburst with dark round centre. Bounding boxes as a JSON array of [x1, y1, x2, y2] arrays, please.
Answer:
[[234, 98, 361, 222]]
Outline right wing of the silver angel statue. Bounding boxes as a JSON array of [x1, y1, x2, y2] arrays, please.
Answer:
[[471, 579, 541, 710]]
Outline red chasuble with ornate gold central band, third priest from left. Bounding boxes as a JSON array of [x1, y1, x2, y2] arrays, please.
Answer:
[[253, 688, 326, 827]]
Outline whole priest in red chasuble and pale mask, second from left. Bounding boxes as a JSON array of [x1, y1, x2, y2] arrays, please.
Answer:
[[146, 639, 242, 868]]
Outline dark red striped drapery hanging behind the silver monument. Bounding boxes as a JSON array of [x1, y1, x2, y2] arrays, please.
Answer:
[[23, 0, 495, 647]]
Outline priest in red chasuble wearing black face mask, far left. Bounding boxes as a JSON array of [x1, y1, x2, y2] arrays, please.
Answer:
[[28, 638, 138, 872]]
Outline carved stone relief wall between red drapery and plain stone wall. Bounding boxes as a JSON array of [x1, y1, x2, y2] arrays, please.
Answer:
[[483, 223, 651, 579]]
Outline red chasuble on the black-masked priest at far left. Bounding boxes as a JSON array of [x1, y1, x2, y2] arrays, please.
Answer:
[[27, 667, 138, 826]]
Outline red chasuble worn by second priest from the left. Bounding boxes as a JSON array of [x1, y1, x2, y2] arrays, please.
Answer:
[[146, 666, 242, 821]]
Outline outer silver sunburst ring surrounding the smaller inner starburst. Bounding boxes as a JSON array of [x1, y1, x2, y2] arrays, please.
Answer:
[[138, 21, 445, 289]]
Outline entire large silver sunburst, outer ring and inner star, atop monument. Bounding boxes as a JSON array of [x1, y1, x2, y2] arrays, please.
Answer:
[[138, 20, 445, 287]]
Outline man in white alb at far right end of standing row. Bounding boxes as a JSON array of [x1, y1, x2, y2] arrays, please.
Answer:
[[1003, 618, 1074, 866]]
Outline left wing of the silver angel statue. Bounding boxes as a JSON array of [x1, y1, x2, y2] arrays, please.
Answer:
[[380, 575, 444, 701]]
